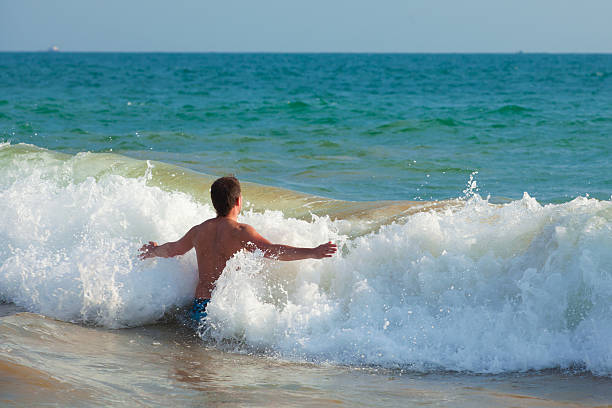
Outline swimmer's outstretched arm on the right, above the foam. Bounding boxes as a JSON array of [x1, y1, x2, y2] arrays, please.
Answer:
[[243, 225, 338, 261]]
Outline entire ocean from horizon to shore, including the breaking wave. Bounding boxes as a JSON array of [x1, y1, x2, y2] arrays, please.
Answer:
[[0, 53, 612, 407]]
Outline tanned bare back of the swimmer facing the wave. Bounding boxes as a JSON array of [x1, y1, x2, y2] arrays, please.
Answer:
[[193, 217, 246, 298]]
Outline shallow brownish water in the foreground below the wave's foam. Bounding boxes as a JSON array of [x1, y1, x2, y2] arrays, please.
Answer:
[[0, 305, 612, 407]]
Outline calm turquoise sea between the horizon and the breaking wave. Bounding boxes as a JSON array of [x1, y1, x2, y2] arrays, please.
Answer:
[[0, 53, 612, 203]]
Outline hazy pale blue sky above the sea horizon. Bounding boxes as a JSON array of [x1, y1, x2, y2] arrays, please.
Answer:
[[0, 0, 612, 52]]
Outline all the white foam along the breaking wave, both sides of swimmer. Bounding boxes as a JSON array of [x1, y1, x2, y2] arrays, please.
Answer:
[[0, 146, 612, 375]]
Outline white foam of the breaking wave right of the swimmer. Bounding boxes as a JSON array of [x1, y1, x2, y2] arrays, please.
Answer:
[[206, 195, 612, 374]]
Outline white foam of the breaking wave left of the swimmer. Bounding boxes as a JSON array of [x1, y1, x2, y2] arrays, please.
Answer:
[[0, 148, 201, 327]]
